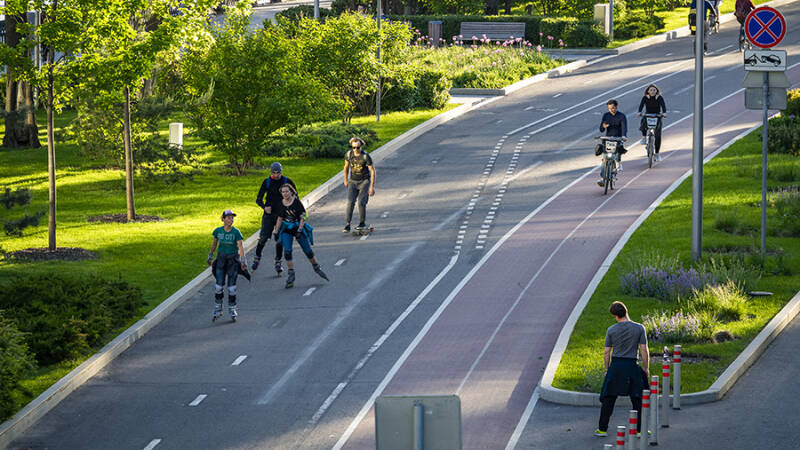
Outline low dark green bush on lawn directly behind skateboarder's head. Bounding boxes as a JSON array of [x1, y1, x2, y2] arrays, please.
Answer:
[[262, 123, 378, 158]]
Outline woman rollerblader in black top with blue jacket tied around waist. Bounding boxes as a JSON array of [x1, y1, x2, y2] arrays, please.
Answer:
[[273, 183, 330, 289]]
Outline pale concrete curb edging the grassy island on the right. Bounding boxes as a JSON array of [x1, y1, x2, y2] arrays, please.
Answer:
[[539, 119, 800, 407]]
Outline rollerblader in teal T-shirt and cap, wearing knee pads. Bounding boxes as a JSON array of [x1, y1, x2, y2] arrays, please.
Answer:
[[206, 209, 247, 322]]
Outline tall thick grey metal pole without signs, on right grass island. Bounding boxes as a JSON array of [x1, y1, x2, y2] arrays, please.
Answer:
[[692, 0, 706, 261]]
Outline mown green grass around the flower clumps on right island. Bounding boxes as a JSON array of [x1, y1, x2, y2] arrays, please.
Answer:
[[553, 126, 800, 393]]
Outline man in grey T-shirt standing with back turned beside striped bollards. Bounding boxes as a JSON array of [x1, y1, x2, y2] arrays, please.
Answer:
[[594, 302, 650, 436]]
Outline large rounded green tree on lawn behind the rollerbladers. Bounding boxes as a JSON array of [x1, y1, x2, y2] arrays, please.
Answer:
[[180, 4, 342, 175]]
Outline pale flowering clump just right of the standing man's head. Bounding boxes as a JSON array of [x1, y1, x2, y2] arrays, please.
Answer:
[[642, 311, 713, 344]]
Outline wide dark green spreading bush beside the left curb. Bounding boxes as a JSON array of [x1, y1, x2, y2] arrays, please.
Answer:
[[0, 274, 145, 365]]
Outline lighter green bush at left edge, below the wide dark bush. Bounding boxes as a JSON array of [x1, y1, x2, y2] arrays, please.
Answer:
[[0, 311, 34, 421]]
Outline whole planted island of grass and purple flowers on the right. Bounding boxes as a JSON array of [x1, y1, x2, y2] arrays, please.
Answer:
[[553, 118, 800, 393]]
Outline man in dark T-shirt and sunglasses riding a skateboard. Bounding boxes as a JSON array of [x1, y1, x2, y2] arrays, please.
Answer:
[[342, 137, 375, 233]]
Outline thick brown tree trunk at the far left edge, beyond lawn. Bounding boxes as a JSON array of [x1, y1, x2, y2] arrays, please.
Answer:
[[3, 14, 42, 148]]
